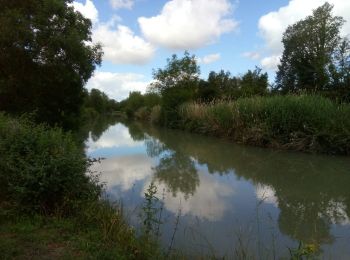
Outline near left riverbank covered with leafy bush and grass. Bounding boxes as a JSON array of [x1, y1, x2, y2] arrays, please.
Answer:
[[0, 114, 156, 259]]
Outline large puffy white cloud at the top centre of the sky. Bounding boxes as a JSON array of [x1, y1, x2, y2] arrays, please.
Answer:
[[138, 0, 238, 49]]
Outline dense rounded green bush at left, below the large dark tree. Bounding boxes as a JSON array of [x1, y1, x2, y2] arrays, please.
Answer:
[[0, 114, 101, 214]]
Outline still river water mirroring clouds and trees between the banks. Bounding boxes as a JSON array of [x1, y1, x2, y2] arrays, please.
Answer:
[[86, 122, 350, 259]]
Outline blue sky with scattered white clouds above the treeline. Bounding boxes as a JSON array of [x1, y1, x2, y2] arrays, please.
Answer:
[[72, 0, 350, 101]]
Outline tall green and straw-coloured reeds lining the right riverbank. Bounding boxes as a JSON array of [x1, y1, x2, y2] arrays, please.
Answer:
[[179, 95, 350, 154]]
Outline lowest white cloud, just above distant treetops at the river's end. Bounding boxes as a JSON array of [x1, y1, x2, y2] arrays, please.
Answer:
[[86, 71, 150, 101]]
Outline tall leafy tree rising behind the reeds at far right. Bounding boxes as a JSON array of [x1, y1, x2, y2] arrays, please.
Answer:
[[276, 3, 344, 98]]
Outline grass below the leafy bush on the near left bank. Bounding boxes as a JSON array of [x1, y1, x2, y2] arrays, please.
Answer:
[[0, 201, 157, 259]]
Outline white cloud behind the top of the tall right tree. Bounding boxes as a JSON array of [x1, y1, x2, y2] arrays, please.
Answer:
[[259, 0, 350, 69]]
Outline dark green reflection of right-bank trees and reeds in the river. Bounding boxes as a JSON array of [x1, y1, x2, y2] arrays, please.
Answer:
[[137, 123, 350, 249]]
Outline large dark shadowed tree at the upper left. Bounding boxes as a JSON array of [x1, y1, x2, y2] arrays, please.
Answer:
[[0, 0, 102, 127]]
